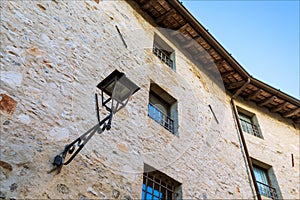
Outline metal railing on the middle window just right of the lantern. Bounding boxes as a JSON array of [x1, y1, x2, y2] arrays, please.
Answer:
[[148, 103, 174, 134]]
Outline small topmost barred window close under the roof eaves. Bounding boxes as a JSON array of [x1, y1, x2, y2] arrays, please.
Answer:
[[153, 35, 175, 71]]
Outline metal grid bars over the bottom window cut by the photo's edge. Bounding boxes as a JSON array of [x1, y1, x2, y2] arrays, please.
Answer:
[[142, 172, 177, 200]]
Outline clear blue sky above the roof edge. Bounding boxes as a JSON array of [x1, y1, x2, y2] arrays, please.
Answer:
[[180, 0, 300, 99]]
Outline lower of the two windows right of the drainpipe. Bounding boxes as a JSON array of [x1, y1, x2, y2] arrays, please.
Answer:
[[253, 165, 278, 199]]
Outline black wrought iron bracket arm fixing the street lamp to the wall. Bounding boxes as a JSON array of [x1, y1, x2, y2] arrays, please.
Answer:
[[53, 113, 113, 173]]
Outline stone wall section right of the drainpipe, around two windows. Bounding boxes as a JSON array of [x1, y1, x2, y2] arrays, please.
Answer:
[[237, 99, 300, 199]]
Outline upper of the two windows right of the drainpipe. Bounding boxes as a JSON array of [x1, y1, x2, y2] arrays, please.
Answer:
[[238, 109, 263, 138]]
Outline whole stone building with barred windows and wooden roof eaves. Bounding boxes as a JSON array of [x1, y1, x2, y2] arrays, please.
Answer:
[[0, 0, 300, 199]]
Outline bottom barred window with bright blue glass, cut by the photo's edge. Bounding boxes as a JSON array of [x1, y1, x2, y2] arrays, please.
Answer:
[[141, 166, 182, 200]]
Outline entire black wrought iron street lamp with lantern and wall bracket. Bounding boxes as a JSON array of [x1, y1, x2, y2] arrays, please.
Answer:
[[53, 70, 140, 173]]
